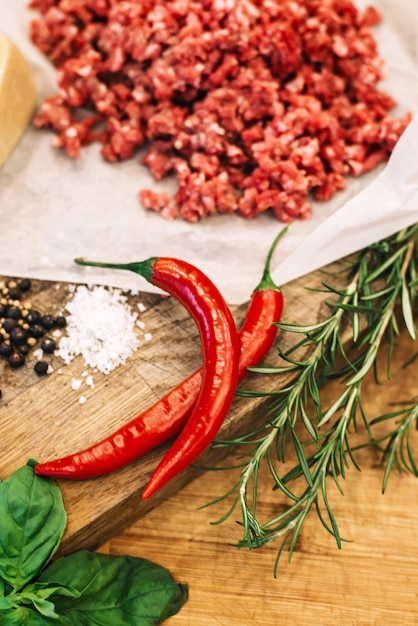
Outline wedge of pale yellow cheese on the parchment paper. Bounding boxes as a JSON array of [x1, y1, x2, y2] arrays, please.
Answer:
[[0, 33, 36, 167]]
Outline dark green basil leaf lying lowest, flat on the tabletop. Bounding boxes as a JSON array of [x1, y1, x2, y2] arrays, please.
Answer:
[[39, 550, 188, 626]]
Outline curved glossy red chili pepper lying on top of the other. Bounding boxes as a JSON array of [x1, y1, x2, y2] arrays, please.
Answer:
[[36, 252, 239, 492]]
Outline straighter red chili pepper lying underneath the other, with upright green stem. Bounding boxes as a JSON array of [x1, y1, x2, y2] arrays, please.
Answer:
[[35, 228, 287, 488]]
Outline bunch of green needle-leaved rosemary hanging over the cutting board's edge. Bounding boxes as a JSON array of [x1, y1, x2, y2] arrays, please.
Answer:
[[206, 225, 418, 574]]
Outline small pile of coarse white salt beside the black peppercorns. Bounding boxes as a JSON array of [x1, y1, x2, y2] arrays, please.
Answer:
[[55, 285, 143, 378]]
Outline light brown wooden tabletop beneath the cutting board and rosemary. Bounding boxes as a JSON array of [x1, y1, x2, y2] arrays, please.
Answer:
[[107, 326, 418, 626]]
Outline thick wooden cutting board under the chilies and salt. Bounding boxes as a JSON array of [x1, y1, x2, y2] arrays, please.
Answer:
[[0, 265, 352, 554]]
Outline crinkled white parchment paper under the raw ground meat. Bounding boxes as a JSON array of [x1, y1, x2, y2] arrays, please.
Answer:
[[0, 0, 418, 304]]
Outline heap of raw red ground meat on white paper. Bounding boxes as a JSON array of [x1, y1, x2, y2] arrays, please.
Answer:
[[30, 0, 411, 222]]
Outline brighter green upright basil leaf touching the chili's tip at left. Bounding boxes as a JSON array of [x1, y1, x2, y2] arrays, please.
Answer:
[[0, 462, 67, 591]]
